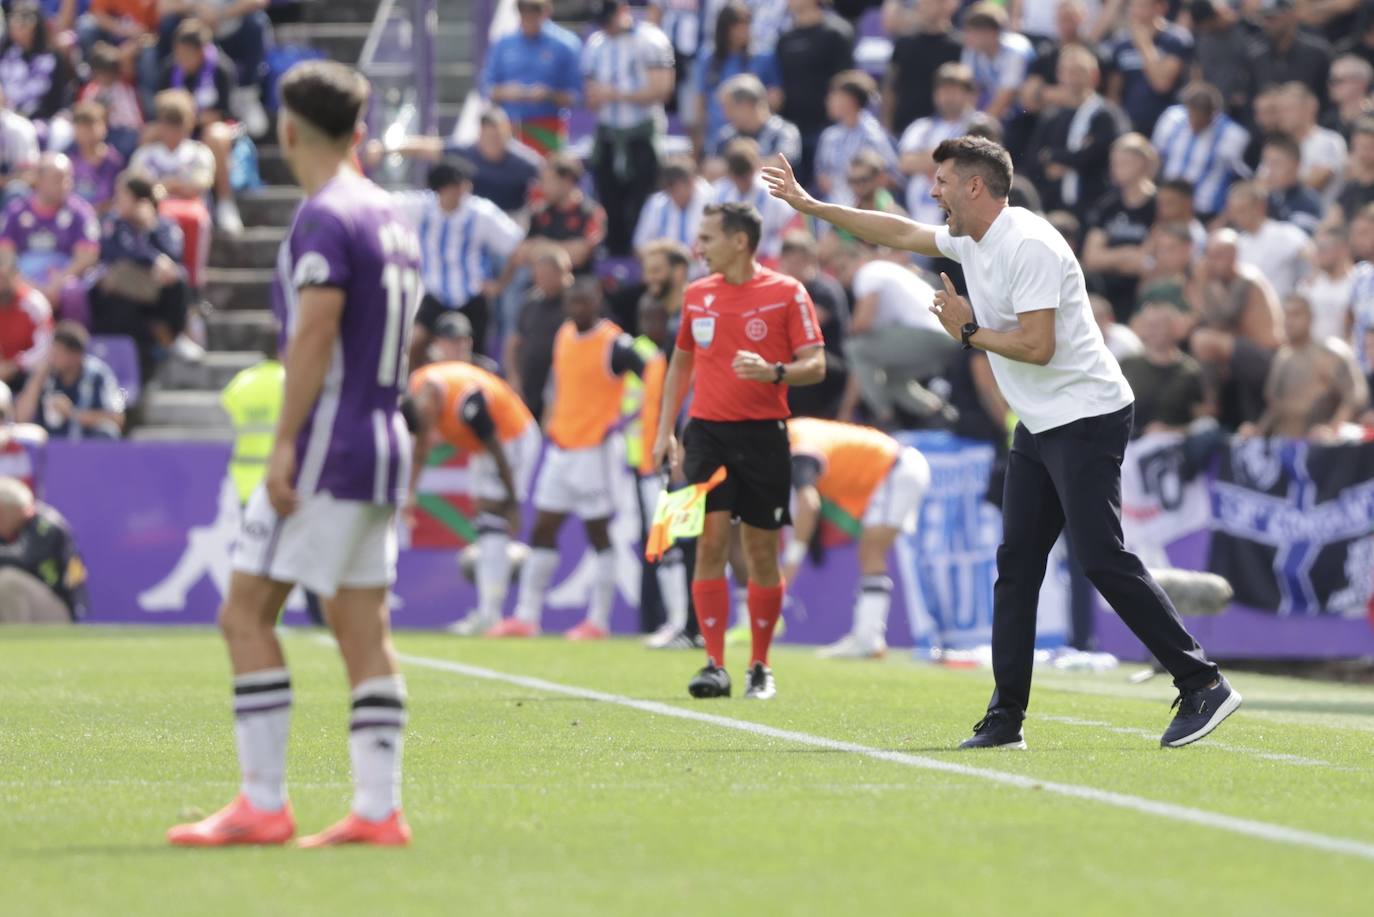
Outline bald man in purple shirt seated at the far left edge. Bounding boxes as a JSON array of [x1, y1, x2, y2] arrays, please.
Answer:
[[0, 153, 100, 317]]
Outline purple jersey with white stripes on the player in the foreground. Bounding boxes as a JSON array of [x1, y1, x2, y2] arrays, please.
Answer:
[[275, 173, 420, 505]]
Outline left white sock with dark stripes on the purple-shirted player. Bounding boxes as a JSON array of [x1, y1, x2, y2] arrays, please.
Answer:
[[234, 668, 291, 813]]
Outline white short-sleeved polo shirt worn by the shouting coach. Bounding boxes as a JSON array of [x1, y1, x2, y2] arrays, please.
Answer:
[[936, 208, 1135, 433]]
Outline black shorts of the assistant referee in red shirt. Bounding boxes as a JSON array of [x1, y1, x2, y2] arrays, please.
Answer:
[[683, 419, 791, 529]]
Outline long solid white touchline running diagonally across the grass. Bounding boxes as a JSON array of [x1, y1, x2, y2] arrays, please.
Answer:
[[397, 653, 1374, 861]]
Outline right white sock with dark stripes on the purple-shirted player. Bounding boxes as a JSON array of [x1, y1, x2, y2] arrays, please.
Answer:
[[348, 675, 405, 822]]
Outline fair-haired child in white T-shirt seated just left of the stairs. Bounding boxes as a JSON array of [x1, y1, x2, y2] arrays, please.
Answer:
[[129, 89, 214, 289]]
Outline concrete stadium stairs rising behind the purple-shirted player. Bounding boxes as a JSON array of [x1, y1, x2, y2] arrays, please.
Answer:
[[129, 0, 475, 441]]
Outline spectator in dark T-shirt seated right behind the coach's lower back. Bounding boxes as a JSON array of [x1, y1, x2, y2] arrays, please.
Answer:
[[1121, 300, 1212, 439]]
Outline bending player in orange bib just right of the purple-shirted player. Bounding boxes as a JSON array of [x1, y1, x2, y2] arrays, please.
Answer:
[[403, 360, 541, 637]]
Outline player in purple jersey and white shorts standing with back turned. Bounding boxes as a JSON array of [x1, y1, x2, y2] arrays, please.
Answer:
[[168, 60, 420, 847]]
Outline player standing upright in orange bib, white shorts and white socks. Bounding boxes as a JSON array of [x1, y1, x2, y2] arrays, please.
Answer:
[[486, 279, 644, 639]]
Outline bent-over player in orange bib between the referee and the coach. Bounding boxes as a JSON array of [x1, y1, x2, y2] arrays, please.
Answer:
[[783, 417, 930, 659]]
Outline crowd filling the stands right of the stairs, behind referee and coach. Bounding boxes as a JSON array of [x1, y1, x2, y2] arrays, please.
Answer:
[[379, 0, 1374, 456]]
